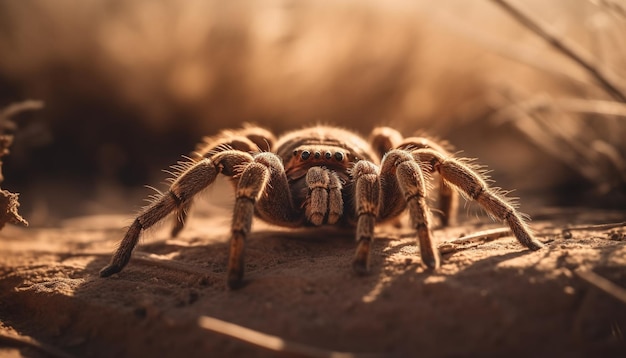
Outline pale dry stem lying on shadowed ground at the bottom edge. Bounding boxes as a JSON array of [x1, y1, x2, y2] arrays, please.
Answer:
[[198, 316, 380, 358]]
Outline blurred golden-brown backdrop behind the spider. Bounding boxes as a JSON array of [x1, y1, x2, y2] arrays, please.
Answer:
[[0, 0, 626, 225]]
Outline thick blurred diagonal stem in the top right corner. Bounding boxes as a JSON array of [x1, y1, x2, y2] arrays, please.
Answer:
[[492, 0, 626, 102]]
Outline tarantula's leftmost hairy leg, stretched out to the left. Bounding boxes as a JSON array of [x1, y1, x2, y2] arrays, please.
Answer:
[[100, 151, 252, 277]]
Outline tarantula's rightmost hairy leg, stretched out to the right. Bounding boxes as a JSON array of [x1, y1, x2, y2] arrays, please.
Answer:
[[412, 149, 544, 250]]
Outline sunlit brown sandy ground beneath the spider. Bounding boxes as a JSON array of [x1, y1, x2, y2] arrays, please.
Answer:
[[0, 200, 626, 357]]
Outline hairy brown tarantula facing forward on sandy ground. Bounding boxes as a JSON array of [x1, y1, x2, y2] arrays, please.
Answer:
[[100, 126, 543, 288]]
